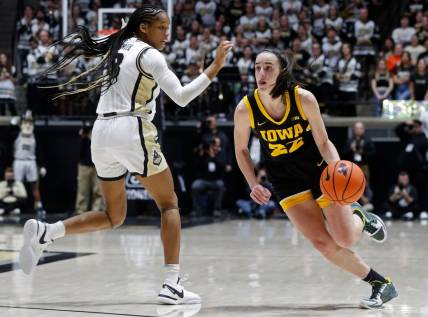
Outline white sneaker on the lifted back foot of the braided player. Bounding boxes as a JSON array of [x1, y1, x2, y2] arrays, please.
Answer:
[[19, 219, 52, 274]]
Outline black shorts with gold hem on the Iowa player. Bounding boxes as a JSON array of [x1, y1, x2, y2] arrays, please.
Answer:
[[266, 155, 330, 211]]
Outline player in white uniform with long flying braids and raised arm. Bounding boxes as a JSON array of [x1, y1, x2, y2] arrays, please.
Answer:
[[20, 5, 232, 304]]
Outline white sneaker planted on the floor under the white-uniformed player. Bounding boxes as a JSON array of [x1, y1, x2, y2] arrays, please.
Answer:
[[158, 279, 201, 305]]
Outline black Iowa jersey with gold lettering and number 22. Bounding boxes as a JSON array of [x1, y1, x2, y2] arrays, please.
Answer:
[[244, 86, 326, 208]]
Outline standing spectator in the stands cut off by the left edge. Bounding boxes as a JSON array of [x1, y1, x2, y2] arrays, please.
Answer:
[[0, 53, 17, 116]]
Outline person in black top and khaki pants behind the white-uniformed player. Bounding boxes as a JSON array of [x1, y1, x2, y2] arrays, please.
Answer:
[[76, 127, 103, 214]]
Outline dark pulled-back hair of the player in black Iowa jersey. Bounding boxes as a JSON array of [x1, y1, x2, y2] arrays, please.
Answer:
[[259, 50, 300, 98]]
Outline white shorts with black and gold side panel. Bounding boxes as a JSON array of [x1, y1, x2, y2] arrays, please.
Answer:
[[91, 116, 168, 181]]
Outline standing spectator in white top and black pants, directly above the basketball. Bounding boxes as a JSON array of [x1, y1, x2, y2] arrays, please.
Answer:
[[335, 43, 361, 117]]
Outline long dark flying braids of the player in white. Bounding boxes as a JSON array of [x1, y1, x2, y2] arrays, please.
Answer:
[[42, 4, 165, 98]]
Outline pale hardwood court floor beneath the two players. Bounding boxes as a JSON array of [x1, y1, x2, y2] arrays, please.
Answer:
[[0, 220, 428, 317]]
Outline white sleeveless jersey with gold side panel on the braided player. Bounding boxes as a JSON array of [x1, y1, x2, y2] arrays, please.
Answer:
[[97, 37, 160, 121]]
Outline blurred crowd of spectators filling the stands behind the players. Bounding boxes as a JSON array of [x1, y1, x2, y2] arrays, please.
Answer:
[[0, 0, 428, 119]]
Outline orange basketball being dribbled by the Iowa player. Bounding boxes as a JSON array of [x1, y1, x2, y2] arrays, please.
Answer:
[[320, 160, 366, 205]]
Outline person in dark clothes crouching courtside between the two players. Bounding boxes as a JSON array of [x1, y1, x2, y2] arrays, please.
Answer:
[[192, 137, 225, 216]]
